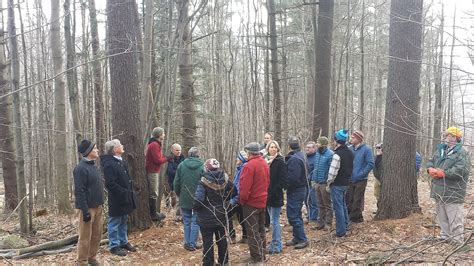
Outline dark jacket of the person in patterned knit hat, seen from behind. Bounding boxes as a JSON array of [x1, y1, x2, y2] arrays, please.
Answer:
[[193, 170, 237, 228]]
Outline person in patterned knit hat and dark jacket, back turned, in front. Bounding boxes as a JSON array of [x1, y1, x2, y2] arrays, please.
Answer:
[[193, 159, 236, 265]]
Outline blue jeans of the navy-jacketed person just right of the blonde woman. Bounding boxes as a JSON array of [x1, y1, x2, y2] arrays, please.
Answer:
[[286, 187, 307, 243]]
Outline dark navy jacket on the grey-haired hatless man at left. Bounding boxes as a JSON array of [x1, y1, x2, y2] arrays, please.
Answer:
[[100, 155, 137, 217]]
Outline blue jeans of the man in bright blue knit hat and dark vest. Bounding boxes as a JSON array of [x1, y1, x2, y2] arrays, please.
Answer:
[[331, 186, 349, 236]]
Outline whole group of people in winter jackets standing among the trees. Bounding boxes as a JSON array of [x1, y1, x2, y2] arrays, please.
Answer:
[[70, 127, 470, 265]]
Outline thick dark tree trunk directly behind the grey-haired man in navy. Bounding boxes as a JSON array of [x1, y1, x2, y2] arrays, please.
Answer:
[[107, 0, 151, 230]]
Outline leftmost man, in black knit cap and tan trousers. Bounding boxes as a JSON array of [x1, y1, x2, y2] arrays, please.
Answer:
[[73, 139, 104, 265]]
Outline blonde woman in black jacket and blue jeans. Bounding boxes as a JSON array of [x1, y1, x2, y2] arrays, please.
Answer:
[[265, 140, 287, 254]]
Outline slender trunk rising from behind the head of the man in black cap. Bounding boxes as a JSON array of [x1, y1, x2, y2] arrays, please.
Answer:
[[64, 0, 83, 150]]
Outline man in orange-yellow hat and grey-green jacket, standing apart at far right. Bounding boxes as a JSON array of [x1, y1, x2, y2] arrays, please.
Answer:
[[426, 127, 471, 244]]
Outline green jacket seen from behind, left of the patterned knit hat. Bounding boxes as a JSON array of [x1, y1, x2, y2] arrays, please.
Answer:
[[173, 157, 204, 209]]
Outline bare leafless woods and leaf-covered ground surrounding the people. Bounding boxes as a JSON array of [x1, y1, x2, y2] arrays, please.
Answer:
[[0, 0, 474, 264]]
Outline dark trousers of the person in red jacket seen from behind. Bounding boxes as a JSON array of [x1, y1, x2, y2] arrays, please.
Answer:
[[242, 205, 267, 262]]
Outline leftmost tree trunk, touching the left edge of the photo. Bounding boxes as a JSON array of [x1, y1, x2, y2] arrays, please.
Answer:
[[0, 8, 18, 211]]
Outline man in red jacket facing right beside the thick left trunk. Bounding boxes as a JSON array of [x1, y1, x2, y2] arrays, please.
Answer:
[[145, 127, 168, 221]]
